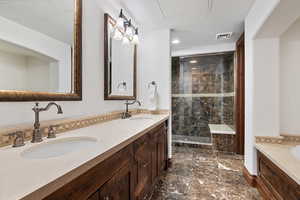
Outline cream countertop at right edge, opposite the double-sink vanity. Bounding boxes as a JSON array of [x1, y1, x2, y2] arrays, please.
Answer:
[[255, 143, 300, 185]]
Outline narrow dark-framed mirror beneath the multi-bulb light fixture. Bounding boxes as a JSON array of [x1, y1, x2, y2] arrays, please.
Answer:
[[104, 14, 137, 100]]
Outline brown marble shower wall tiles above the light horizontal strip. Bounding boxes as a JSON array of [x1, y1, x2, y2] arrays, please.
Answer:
[[172, 53, 234, 94]]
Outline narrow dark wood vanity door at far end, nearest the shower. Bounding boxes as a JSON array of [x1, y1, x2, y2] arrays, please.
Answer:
[[157, 127, 167, 175]]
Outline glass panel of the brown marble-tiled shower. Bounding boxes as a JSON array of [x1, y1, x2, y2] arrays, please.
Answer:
[[172, 52, 234, 144]]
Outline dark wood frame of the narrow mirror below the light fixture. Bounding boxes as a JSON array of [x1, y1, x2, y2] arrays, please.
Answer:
[[104, 13, 137, 100]]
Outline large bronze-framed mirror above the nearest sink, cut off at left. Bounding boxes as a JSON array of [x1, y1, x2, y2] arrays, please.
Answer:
[[0, 0, 82, 101]]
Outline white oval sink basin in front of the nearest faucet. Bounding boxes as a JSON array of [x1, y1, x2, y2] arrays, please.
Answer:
[[21, 137, 97, 159]]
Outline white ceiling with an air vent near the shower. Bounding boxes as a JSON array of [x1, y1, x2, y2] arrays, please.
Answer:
[[117, 0, 255, 50]]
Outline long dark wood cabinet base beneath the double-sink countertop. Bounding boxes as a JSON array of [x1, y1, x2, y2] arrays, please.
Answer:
[[44, 122, 167, 200]]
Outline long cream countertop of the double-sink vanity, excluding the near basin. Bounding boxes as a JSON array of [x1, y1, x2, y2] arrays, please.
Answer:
[[0, 114, 168, 200]]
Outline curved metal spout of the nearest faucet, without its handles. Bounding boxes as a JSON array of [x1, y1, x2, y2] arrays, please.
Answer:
[[31, 102, 63, 143]]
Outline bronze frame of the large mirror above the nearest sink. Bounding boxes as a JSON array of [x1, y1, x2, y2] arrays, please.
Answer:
[[0, 0, 82, 102]]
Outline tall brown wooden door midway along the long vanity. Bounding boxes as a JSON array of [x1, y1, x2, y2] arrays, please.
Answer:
[[134, 135, 151, 199]]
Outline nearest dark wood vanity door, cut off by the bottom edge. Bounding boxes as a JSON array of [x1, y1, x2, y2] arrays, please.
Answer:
[[99, 164, 133, 200]]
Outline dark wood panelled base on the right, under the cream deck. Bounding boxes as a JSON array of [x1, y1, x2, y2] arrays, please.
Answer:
[[257, 151, 300, 200]]
